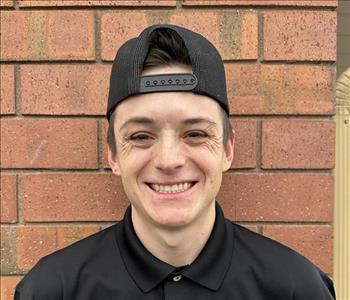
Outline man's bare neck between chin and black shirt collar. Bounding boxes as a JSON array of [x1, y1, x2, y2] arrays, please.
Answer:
[[131, 203, 215, 267]]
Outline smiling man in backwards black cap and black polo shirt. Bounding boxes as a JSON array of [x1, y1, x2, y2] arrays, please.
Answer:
[[16, 25, 335, 300]]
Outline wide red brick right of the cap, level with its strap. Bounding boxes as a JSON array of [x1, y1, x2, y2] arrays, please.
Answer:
[[225, 64, 335, 115]]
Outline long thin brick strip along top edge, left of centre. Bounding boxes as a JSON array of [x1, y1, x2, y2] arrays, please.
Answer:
[[19, 0, 176, 7]]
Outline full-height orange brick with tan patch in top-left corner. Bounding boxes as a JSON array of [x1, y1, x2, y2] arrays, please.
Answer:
[[1, 11, 95, 61]]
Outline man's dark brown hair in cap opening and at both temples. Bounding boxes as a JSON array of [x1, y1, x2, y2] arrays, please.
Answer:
[[107, 28, 233, 155]]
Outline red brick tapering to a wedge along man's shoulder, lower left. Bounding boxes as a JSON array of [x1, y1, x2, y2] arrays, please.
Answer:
[[16, 226, 99, 271]]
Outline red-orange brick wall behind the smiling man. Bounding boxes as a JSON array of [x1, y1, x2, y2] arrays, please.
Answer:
[[0, 0, 337, 300]]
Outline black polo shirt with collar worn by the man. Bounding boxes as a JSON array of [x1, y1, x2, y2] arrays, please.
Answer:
[[15, 204, 335, 300]]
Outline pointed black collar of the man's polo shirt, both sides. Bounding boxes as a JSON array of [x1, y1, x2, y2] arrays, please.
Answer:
[[116, 203, 233, 293]]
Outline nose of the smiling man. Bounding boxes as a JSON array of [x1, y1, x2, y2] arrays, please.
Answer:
[[154, 136, 186, 172]]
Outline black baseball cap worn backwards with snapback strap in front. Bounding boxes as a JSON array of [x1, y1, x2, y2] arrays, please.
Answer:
[[107, 24, 229, 120]]
